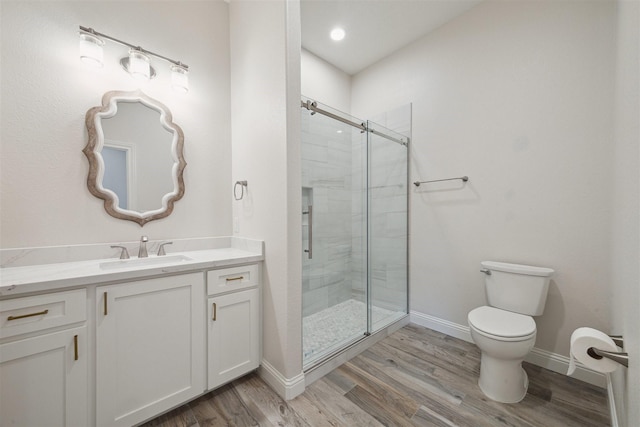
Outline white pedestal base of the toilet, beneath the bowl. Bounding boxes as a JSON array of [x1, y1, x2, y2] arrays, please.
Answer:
[[478, 353, 529, 403]]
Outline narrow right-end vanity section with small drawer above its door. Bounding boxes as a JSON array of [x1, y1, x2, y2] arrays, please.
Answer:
[[207, 264, 261, 390]]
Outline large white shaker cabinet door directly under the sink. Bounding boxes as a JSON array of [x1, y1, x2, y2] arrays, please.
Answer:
[[96, 273, 205, 426]]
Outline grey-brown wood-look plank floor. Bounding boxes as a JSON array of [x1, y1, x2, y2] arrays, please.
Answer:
[[145, 324, 610, 427]]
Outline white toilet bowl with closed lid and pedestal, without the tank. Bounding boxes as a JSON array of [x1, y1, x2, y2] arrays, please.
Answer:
[[468, 306, 536, 403]]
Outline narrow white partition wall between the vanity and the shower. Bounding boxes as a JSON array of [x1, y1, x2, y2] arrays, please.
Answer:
[[230, 0, 304, 397]]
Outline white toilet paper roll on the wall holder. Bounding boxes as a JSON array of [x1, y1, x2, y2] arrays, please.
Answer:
[[567, 328, 619, 375]]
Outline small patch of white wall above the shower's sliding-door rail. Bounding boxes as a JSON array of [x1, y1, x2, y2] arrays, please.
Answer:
[[300, 49, 351, 113]]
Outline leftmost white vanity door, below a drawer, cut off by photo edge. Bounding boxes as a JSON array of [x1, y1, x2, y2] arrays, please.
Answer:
[[0, 326, 89, 427]]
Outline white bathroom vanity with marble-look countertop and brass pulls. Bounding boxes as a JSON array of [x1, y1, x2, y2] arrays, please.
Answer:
[[0, 239, 264, 426]]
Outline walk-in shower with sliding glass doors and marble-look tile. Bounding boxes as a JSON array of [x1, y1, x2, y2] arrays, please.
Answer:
[[301, 98, 410, 369]]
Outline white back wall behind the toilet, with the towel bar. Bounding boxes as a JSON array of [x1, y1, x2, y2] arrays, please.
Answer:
[[352, 1, 615, 356]]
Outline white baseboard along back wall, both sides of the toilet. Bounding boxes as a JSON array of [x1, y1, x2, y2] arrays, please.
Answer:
[[409, 311, 607, 388]]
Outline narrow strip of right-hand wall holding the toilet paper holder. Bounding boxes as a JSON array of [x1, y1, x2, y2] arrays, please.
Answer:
[[611, 1, 640, 427]]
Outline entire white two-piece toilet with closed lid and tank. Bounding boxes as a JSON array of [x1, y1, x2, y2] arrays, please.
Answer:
[[467, 261, 553, 403]]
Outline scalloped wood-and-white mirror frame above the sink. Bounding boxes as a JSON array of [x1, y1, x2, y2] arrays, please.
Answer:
[[82, 90, 187, 227]]
